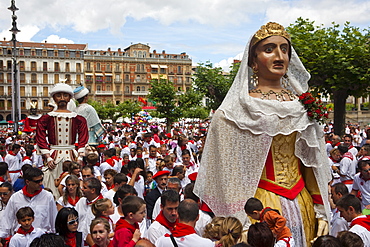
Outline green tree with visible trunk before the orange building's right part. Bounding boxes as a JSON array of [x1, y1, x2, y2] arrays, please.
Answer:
[[148, 78, 181, 132]]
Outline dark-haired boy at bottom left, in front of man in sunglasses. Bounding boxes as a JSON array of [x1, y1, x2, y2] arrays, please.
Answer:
[[9, 207, 44, 247]]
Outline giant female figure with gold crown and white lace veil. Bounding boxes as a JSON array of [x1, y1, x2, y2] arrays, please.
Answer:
[[195, 22, 331, 246]]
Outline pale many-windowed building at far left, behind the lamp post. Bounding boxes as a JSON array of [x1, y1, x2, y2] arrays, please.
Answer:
[[0, 41, 87, 120]]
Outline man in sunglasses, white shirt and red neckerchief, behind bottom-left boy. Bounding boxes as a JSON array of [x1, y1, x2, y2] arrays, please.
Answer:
[[0, 167, 57, 238]]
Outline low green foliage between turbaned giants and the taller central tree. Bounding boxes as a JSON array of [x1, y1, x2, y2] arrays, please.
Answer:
[[88, 100, 141, 123]]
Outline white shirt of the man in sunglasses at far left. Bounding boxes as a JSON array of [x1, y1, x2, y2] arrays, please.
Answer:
[[0, 190, 57, 238]]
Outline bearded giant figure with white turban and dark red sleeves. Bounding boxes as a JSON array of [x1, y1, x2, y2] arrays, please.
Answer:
[[36, 83, 88, 196]]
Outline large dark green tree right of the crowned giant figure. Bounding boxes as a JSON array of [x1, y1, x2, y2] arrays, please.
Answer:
[[287, 18, 370, 135]]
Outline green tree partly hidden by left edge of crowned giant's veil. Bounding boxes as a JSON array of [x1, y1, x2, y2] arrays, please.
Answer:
[[194, 61, 240, 110]]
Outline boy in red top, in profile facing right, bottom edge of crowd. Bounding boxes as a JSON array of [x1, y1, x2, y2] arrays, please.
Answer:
[[113, 196, 146, 247]]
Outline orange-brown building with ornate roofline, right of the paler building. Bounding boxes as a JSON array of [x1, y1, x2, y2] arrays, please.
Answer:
[[84, 43, 192, 104]]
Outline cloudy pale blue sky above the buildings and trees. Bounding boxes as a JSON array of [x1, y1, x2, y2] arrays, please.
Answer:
[[0, 0, 370, 68]]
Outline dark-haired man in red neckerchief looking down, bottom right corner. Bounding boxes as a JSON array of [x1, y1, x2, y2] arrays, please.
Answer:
[[337, 194, 370, 247]]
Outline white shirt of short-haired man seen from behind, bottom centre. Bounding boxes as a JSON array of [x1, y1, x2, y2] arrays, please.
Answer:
[[155, 233, 215, 247]]
